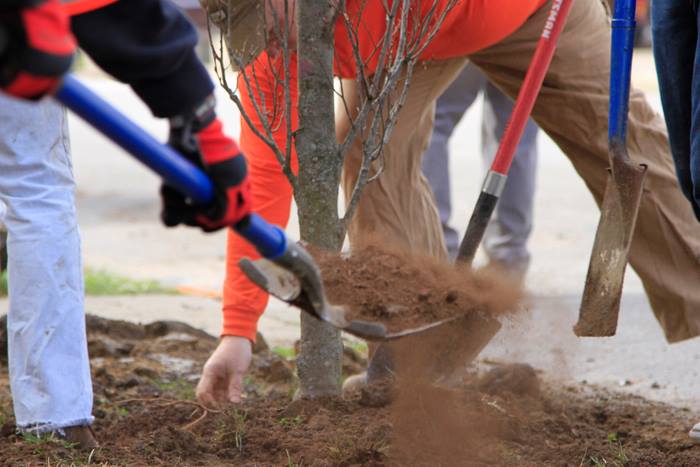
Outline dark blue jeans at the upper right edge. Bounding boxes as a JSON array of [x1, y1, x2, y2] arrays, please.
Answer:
[[651, 0, 700, 221]]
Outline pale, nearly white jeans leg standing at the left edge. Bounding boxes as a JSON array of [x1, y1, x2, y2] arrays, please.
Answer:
[[0, 94, 93, 432]]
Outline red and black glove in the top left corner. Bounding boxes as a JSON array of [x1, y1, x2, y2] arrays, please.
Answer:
[[0, 0, 76, 99]]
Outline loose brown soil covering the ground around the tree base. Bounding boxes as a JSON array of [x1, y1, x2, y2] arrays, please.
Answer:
[[0, 317, 700, 466]]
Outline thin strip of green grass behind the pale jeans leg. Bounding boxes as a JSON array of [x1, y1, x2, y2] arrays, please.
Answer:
[[0, 268, 177, 297]]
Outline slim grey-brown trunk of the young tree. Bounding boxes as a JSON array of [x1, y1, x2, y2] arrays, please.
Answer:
[[295, 0, 343, 397]]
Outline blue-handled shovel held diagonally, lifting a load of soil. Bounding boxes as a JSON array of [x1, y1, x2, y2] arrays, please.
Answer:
[[54, 75, 387, 340]]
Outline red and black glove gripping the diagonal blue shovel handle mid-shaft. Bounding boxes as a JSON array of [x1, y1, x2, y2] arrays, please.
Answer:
[[160, 97, 251, 232]]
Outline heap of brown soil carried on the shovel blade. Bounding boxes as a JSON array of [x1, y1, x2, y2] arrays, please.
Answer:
[[313, 244, 521, 331]]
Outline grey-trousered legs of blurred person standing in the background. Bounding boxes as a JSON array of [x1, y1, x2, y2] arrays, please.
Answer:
[[423, 63, 538, 280]]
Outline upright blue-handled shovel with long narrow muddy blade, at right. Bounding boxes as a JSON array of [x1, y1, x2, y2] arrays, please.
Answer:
[[574, 0, 646, 337]]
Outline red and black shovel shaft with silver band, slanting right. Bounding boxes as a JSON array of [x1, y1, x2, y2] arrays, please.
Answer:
[[457, 0, 576, 264]]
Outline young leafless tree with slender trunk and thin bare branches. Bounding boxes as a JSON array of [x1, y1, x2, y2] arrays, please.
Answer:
[[201, 0, 457, 397]]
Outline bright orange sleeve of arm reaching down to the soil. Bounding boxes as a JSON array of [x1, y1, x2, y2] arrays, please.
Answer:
[[222, 53, 297, 341]]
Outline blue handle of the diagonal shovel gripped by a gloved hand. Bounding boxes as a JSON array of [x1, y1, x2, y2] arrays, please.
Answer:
[[54, 75, 287, 259]]
